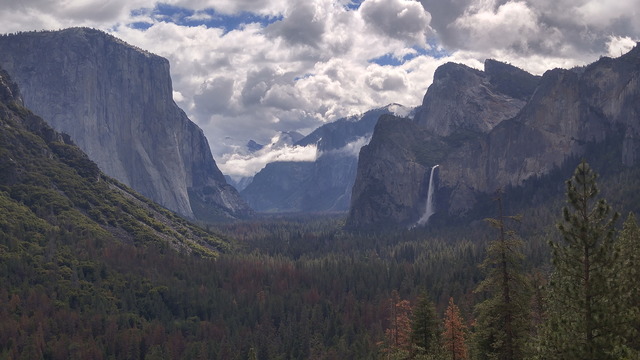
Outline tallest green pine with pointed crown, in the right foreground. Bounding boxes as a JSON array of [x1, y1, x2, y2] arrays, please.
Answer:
[[544, 161, 621, 360]]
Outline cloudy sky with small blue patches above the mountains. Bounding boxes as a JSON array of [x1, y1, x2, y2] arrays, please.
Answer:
[[0, 0, 640, 176]]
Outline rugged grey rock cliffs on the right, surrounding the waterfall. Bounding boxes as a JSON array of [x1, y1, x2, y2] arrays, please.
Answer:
[[347, 46, 640, 228]]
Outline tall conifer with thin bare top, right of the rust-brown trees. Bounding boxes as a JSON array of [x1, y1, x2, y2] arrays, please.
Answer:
[[474, 194, 530, 360]]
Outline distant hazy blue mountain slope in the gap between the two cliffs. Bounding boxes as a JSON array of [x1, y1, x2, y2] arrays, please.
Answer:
[[241, 104, 410, 212]]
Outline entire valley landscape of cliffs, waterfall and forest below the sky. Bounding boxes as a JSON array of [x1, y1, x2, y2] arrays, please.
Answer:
[[0, 28, 640, 360]]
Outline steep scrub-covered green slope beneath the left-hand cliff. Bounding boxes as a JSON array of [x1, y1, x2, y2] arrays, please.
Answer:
[[0, 70, 229, 257]]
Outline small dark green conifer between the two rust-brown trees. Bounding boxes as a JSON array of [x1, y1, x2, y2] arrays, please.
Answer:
[[411, 293, 440, 355]]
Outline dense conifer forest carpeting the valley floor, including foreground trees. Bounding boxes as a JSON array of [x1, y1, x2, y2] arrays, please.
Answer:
[[0, 158, 640, 360]]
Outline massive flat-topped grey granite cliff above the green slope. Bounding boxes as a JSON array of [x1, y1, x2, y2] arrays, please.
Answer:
[[0, 28, 250, 218]]
